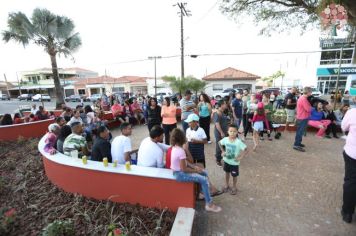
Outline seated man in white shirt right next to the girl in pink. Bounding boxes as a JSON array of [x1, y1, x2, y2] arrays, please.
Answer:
[[137, 125, 170, 168]]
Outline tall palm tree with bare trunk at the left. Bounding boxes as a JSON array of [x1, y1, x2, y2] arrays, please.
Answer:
[[2, 8, 82, 108]]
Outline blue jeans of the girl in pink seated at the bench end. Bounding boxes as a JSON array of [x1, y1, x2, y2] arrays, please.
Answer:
[[173, 171, 213, 204]]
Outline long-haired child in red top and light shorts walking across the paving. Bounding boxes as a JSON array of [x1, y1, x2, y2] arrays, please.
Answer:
[[252, 102, 271, 151]]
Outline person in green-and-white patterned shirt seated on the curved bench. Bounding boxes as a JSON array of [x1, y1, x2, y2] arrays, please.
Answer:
[[63, 122, 89, 157]]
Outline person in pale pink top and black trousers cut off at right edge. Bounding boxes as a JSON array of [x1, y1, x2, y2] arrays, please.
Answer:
[[341, 108, 356, 223]]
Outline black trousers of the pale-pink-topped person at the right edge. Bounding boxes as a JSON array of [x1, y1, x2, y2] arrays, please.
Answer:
[[342, 151, 356, 214]]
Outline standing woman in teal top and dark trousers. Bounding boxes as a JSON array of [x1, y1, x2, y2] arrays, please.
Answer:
[[198, 93, 212, 143]]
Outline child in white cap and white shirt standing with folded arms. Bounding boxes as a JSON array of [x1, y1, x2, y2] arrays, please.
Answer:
[[185, 113, 208, 168]]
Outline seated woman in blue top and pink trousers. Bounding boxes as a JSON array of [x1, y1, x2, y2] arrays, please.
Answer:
[[308, 102, 331, 138]]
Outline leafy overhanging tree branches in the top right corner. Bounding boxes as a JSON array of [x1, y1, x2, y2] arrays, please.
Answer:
[[220, 0, 356, 35]]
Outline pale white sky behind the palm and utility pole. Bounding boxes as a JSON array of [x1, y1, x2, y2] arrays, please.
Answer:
[[0, 0, 328, 85]]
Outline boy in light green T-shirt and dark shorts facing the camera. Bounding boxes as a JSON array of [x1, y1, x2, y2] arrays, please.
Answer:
[[219, 125, 247, 195]]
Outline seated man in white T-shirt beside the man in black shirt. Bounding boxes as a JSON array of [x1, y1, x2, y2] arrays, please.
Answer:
[[111, 122, 137, 164]]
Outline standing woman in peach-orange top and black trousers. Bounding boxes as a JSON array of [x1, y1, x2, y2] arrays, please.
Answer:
[[161, 97, 177, 145]]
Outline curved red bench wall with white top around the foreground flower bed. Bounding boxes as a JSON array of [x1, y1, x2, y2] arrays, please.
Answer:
[[38, 136, 195, 211]]
